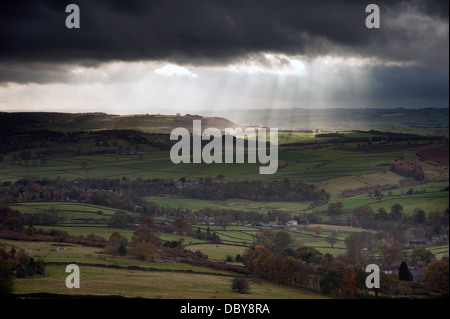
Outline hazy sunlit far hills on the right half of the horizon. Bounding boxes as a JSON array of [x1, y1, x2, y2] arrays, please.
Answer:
[[214, 108, 449, 135]]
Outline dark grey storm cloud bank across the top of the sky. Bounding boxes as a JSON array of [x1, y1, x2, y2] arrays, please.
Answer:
[[0, 0, 448, 65]]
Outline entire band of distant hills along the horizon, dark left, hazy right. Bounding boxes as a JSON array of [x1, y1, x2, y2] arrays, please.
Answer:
[[0, 108, 449, 136]]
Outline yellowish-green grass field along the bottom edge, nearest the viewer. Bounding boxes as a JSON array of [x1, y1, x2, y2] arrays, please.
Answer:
[[14, 266, 326, 299]]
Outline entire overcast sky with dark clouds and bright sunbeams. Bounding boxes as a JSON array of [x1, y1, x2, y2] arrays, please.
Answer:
[[0, 0, 449, 114]]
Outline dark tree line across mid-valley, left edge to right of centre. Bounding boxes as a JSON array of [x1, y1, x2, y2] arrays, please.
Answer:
[[0, 177, 329, 211]]
